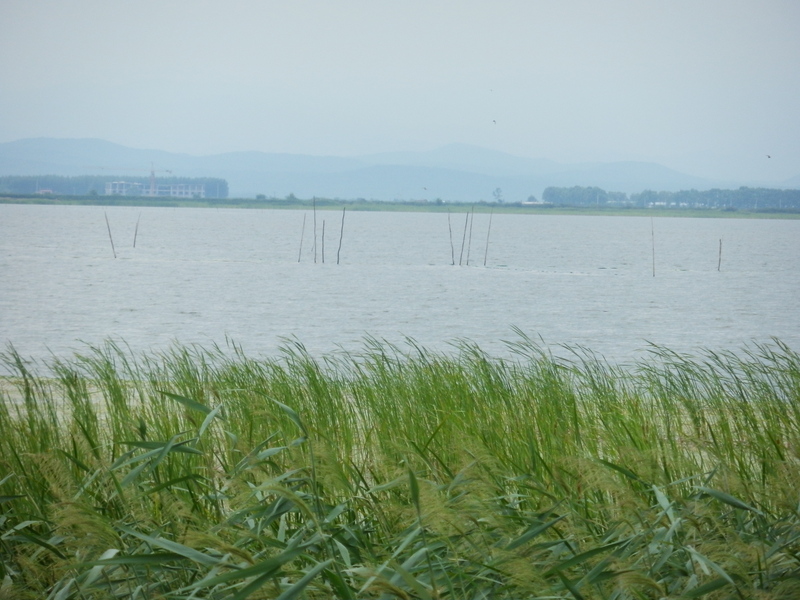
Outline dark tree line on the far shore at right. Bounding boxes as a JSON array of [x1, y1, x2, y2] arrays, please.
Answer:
[[542, 186, 800, 210]]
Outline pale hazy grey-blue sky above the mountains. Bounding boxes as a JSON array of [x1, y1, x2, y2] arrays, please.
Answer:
[[0, 0, 800, 183]]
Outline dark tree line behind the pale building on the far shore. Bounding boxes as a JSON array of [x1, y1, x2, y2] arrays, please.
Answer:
[[0, 175, 228, 198]]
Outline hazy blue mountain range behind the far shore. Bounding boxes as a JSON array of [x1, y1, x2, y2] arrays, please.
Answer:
[[0, 138, 800, 202]]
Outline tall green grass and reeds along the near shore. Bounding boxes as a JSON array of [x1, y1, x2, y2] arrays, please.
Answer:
[[0, 336, 800, 600]]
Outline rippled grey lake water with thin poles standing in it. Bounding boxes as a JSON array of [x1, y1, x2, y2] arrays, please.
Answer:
[[0, 205, 800, 362]]
